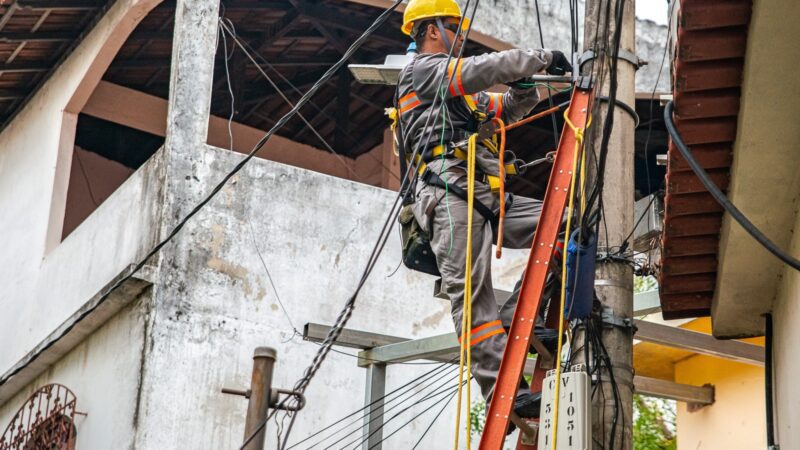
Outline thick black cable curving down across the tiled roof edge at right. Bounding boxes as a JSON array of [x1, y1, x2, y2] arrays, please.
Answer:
[[664, 101, 800, 270]]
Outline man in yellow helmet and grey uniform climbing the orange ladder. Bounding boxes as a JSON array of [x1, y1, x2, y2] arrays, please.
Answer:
[[395, 0, 572, 424]]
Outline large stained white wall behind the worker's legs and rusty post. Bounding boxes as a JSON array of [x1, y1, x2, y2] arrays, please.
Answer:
[[130, 143, 524, 449]]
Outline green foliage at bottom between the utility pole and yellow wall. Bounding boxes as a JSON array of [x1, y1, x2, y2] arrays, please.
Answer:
[[633, 395, 678, 450]]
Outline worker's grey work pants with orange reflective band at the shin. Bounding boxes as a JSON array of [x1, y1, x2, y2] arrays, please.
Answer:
[[414, 168, 542, 399]]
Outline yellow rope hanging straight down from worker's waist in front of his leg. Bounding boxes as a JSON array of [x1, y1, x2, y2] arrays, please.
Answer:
[[453, 134, 478, 450]]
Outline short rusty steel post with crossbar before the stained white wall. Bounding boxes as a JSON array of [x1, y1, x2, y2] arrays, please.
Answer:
[[244, 347, 278, 450]]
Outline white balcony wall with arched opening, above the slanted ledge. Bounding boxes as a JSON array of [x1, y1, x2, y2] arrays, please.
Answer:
[[0, 0, 163, 372]]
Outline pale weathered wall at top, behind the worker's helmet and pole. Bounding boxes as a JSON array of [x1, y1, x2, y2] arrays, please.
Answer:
[[459, 0, 670, 93]]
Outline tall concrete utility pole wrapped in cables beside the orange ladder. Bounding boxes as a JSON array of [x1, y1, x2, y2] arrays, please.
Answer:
[[576, 0, 636, 450]]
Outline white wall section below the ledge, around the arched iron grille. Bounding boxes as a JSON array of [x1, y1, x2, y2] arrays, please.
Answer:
[[0, 296, 150, 450]]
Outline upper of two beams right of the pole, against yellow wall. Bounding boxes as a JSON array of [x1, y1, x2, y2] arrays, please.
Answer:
[[634, 320, 764, 366]]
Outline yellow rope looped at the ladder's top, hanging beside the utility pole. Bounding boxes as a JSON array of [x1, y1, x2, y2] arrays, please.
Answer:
[[552, 108, 588, 450]]
